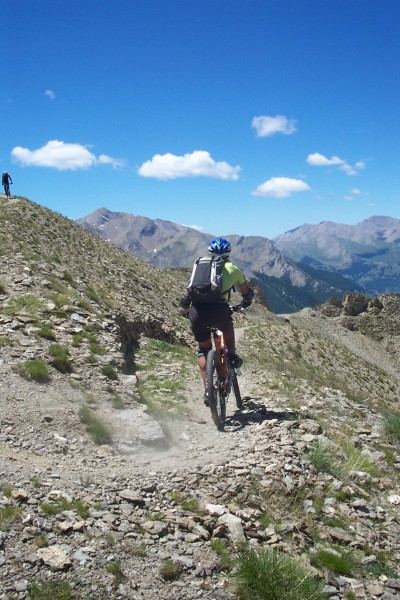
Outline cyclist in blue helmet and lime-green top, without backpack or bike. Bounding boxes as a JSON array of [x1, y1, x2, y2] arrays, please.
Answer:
[[180, 237, 254, 404]]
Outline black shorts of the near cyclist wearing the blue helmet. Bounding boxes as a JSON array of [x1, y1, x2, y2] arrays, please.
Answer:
[[189, 302, 232, 342]]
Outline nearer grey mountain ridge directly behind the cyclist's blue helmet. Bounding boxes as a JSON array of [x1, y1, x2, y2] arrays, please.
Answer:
[[77, 208, 363, 312]]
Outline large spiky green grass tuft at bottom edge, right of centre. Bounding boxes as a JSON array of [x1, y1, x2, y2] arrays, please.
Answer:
[[231, 547, 326, 600]]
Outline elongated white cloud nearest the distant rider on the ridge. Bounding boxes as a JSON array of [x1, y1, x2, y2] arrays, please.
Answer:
[[11, 140, 124, 171]]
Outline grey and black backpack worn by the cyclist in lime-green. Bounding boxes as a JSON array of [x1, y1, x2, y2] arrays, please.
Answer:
[[186, 256, 225, 304]]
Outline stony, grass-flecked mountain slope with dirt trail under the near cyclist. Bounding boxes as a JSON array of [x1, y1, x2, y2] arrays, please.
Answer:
[[0, 199, 400, 600]]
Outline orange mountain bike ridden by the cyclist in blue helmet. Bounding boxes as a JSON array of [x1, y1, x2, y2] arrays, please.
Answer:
[[206, 303, 245, 431]]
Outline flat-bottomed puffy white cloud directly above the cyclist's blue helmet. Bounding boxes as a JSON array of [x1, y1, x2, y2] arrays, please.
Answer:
[[138, 150, 240, 180]]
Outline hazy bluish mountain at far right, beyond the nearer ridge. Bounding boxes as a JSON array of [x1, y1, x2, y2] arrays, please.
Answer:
[[274, 216, 400, 294]]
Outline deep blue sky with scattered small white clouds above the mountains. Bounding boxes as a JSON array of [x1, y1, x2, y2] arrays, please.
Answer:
[[0, 0, 400, 238]]
